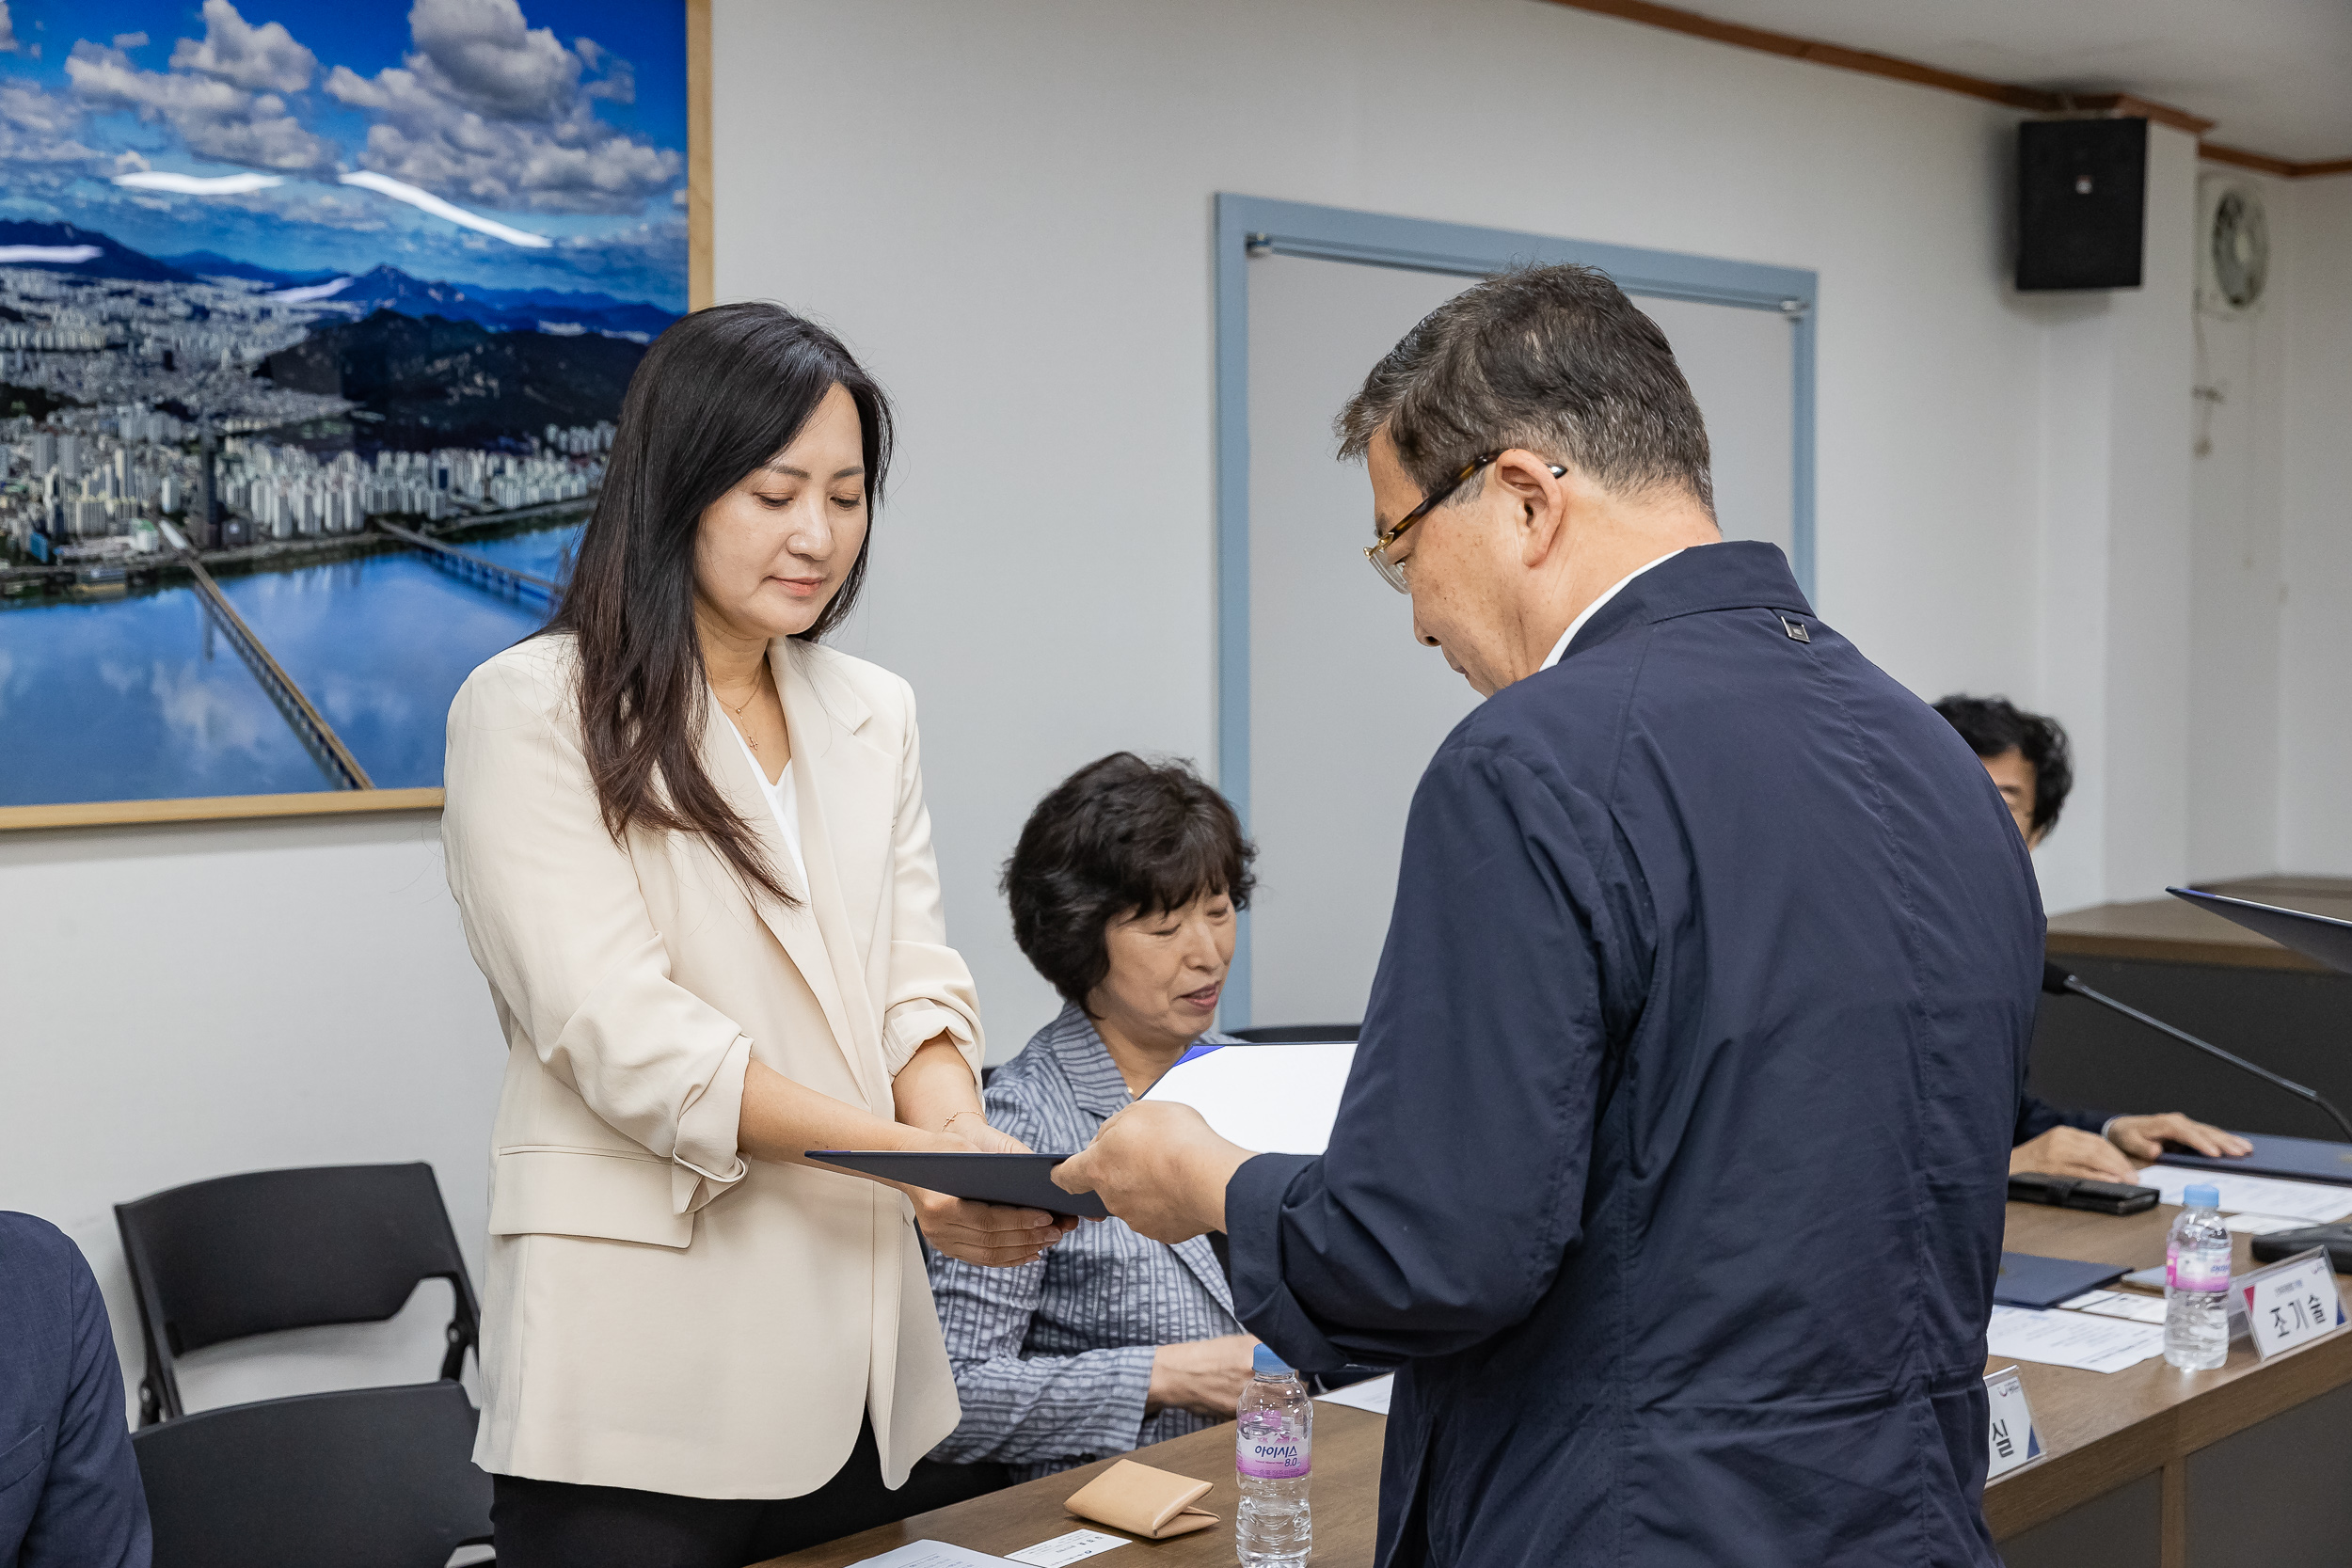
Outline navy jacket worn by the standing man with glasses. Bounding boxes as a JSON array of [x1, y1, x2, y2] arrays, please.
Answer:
[[1226, 543, 2042, 1568]]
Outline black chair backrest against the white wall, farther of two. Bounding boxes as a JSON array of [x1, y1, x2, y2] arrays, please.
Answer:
[[116, 1164, 480, 1425]]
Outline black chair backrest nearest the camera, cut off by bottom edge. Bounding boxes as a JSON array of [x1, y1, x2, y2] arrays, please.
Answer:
[[132, 1383, 489, 1568]]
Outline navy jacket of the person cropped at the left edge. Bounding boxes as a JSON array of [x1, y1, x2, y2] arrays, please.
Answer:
[[0, 1213, 149, 1568]]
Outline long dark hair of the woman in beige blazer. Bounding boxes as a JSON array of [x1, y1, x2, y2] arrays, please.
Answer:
[[546, 303, 892, 905]]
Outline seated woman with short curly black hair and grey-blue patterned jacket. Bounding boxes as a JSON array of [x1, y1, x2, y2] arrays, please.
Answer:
[[931, 752, 1256, 1481]]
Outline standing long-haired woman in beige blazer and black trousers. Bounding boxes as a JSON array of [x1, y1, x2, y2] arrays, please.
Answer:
[[442, 306, 1068, 1568]]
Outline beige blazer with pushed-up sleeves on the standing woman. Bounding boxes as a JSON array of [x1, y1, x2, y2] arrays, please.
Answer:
[[442, 637, 981, 1497]]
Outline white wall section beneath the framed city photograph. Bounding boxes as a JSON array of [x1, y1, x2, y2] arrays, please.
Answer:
[[0, 814, 506, 1408]]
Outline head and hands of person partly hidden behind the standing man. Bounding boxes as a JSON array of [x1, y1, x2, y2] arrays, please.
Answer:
[[1936, 693, 2253, 1182]]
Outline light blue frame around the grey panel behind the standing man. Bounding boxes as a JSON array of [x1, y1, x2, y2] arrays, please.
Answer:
[[1216, 193, 1820, 1030]]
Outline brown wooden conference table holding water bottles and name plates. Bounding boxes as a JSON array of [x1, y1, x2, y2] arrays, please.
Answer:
[[760, 1204, 2352, 1568]]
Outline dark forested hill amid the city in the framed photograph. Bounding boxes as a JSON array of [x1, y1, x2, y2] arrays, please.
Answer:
[[262, 309, 644, 449]]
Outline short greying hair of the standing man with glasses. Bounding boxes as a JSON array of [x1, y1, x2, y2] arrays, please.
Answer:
[[1334, 265, 1715, 513]]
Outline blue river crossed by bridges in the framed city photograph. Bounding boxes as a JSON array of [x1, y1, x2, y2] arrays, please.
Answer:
[[0, 522, 579, 806]]
